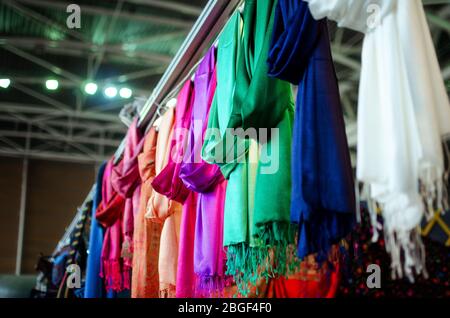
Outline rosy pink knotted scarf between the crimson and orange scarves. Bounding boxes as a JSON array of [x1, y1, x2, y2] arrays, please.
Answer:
[[111, 118, 144, 289]]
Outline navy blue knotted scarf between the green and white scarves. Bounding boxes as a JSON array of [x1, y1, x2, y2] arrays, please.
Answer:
[[268, 0, 356, 258]]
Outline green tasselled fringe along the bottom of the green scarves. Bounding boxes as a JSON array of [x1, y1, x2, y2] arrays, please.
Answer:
[[226, 222, 300, 297]]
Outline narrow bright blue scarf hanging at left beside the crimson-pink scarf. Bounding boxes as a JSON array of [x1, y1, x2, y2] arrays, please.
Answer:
[[84, 163, 106, 298]]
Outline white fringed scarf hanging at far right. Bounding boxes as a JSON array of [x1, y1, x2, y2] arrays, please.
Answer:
[[308, 0, 450, 281]]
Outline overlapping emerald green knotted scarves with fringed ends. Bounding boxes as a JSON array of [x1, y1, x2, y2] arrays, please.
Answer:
[[202, 0, 297, 295]]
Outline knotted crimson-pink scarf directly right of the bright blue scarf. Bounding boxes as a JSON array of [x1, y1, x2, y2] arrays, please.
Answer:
[[95, 159, 126, 291]]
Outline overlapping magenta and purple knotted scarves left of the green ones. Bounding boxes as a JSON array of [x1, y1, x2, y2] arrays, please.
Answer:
[[152, 48, 226, 297]]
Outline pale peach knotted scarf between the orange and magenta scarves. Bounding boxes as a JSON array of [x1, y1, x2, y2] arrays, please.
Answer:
[[145, 108, 182, 298]]
